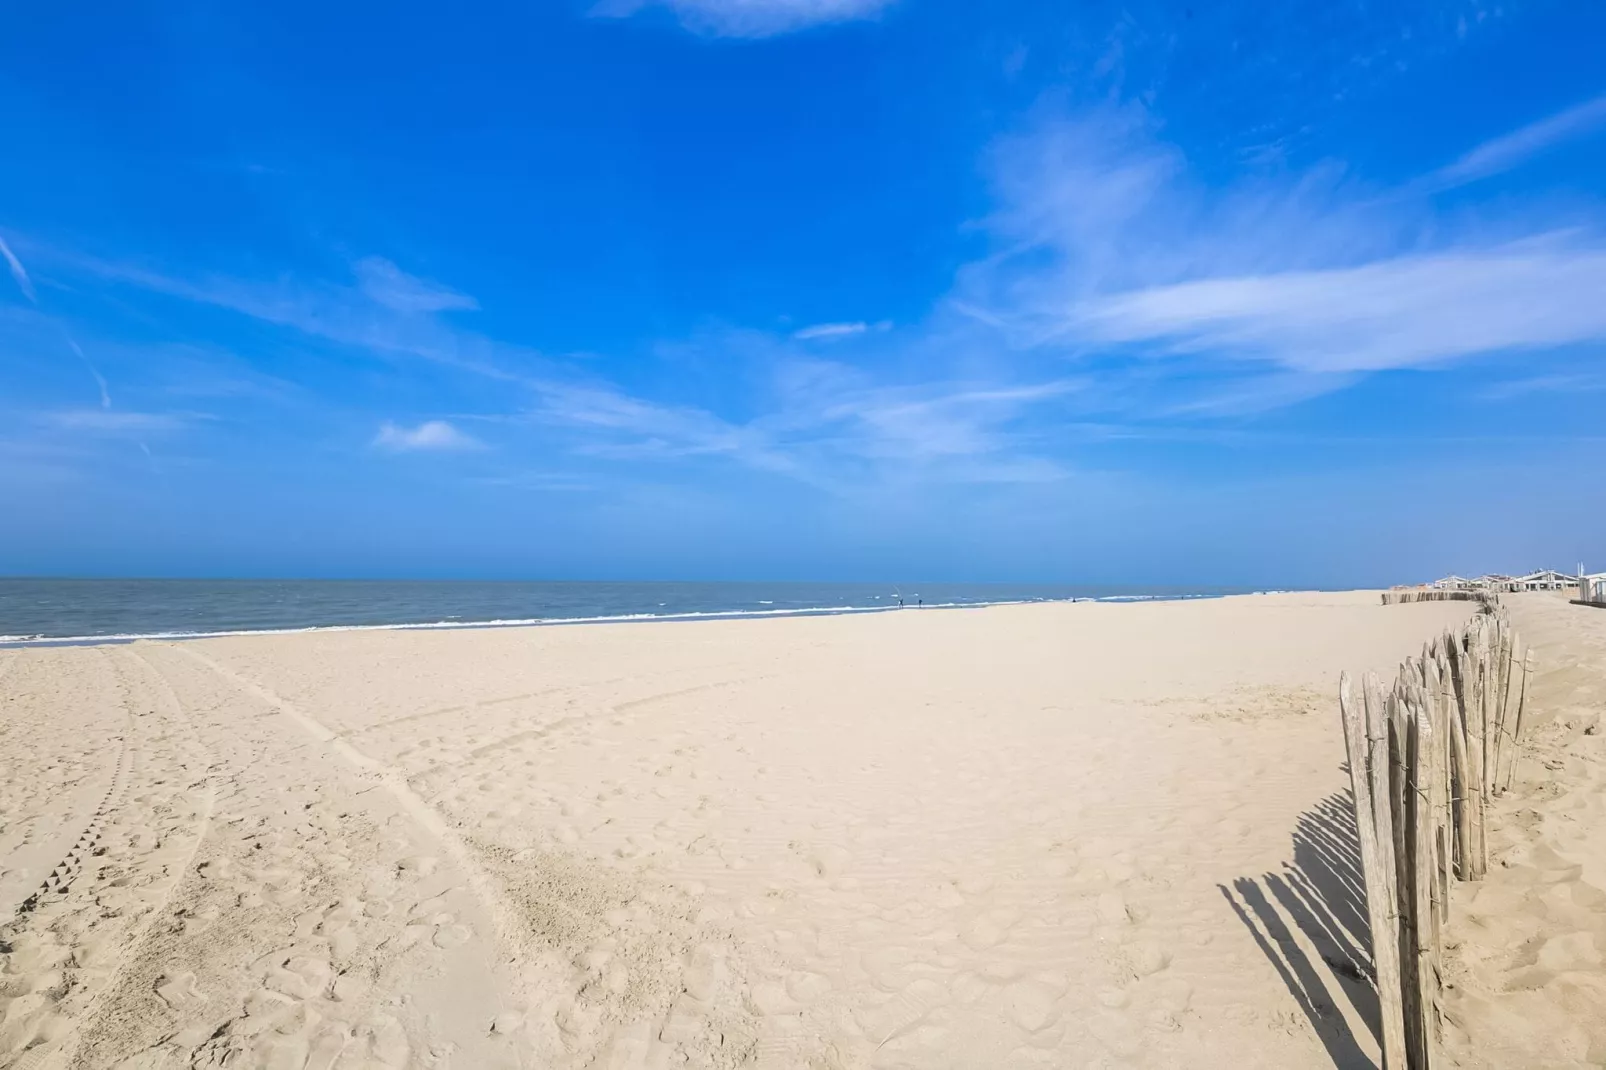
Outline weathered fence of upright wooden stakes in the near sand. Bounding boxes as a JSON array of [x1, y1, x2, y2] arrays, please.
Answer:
[[1338, 607, 1532, 1070]]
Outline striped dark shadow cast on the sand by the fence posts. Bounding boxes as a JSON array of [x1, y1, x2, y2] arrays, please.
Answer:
[[1217, 766, 1380, 1070]]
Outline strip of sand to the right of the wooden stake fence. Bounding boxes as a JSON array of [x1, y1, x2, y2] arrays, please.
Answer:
[[1445, 594, 1606, 1070]]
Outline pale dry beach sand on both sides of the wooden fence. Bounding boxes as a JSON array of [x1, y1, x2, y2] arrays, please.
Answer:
[[0, 593, 1606, 1070]]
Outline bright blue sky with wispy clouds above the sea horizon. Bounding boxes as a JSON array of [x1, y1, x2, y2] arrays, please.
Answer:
[[0, 0, 1606, 585]]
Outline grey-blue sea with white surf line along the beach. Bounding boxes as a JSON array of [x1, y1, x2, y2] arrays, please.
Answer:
[[0, 578, 1240, 646]]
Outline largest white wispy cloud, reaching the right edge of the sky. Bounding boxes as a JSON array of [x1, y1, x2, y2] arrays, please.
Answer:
[[956, 109, 1606, 380]]
